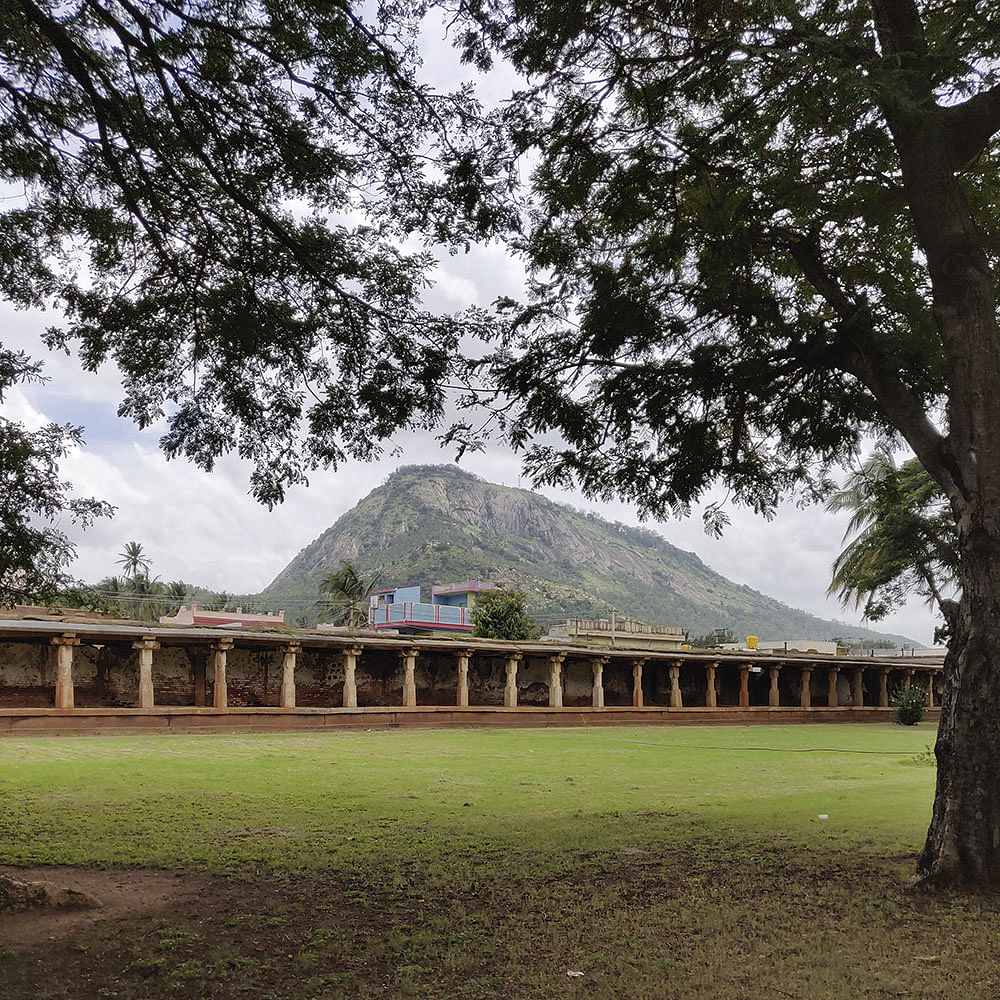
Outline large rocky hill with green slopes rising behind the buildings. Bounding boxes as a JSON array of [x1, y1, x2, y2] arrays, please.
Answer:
[[261, 465, 916, 639]]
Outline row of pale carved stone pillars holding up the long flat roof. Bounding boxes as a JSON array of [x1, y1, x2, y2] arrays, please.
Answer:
[[45, 633, 934, 708]]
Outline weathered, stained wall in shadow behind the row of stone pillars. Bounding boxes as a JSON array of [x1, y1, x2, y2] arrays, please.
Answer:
[[0, 638, 941, 708]]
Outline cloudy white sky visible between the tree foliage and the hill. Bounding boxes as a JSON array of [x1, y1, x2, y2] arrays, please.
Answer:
[[0, 11, 935, 644]]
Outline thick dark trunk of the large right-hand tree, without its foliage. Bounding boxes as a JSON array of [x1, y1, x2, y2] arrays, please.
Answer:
[[872, 0, 1000, 889]]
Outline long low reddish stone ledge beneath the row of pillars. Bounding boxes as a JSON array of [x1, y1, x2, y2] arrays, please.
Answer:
[[0, 705, 940, 736]]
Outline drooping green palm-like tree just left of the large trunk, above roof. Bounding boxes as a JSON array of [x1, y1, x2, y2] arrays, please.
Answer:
[[826, 451, 958, 621]]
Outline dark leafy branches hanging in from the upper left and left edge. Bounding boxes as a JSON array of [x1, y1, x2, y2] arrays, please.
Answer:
[[0, 0, 500, 599]]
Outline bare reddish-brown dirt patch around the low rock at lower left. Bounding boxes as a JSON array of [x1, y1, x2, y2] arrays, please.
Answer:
[[0, 867, 211, 949]]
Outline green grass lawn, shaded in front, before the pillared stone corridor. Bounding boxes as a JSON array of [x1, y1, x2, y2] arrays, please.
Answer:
[[0, 725, 1000, 1000]]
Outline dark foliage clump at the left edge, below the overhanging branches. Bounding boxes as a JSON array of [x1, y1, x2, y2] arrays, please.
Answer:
[[0, 345, 112, 605]]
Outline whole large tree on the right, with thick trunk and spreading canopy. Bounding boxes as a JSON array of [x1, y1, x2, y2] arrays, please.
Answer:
[[453, 0, 1000, 887]]
